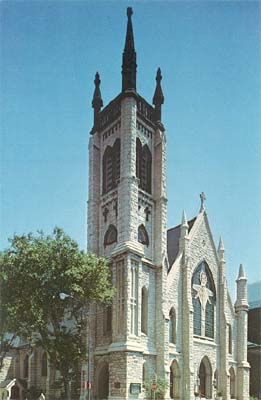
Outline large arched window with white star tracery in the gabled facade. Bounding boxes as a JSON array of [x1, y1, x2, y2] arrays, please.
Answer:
[[192, 262, 216, 339]]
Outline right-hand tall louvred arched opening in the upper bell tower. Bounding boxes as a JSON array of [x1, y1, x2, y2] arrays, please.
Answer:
[[136, 138, 152, 193]]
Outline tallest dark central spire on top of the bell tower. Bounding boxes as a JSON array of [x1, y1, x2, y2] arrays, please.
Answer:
[[122, 7, 137, 92]]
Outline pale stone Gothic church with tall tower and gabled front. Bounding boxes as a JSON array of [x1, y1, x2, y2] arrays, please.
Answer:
[[84, 7, 249, 400]]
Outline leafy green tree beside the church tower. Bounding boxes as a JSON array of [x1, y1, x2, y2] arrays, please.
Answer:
[[0, 228, 114, 399]]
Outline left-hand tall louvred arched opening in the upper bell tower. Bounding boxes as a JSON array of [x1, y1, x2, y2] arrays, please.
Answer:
[[102, 139, 121, 194]]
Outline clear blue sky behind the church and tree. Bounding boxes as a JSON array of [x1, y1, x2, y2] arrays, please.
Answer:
[[0, 1, 261, 294]]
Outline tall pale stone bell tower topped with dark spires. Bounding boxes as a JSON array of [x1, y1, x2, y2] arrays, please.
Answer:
[[85, 7, 167, 399]]
